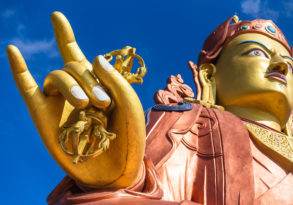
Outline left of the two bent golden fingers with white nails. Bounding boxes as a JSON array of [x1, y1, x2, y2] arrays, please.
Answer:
[[44, 70, 89, 109]]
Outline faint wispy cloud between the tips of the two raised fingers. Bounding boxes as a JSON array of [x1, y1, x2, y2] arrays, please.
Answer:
[[10, 38, 58, 59]]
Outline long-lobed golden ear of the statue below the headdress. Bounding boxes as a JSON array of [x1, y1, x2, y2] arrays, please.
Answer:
[[199, 63, 216, 105]]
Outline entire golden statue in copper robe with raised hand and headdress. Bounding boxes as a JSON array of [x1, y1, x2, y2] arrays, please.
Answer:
[[7, 12, 293, 205]]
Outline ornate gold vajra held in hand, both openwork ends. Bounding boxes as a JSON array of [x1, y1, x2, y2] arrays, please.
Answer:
[[59, 46, 147, 164]]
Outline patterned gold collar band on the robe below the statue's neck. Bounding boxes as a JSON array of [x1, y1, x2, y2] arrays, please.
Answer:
[[244, 122, 293, 163]]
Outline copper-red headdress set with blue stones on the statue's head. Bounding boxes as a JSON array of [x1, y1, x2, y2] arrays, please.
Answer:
[[198, 16, 293, 65]]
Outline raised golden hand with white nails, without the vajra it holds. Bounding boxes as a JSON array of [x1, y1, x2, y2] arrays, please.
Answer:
[[7, 12, 145, 188]]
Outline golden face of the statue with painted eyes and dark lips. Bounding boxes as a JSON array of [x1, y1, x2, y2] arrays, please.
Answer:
[[215, 33, 293, 124]]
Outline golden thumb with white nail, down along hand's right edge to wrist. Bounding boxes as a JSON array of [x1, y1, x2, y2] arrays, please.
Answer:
[[93, 56, 146, 186]]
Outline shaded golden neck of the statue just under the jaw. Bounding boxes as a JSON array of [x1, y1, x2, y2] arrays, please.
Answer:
[[225, 106, 282, 131]]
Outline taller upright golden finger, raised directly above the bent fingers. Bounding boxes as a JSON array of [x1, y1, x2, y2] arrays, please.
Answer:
[[51, 11, 91, 67]]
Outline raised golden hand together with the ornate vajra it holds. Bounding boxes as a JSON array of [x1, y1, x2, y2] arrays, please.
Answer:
[[7, 12, 146, 188]]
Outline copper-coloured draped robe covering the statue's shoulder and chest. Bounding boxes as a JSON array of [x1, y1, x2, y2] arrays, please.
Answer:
[[48, 104, 293, 205]]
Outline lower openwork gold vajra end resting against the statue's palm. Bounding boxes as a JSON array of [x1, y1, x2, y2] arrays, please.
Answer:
[[59, 108, 116, 164]]
